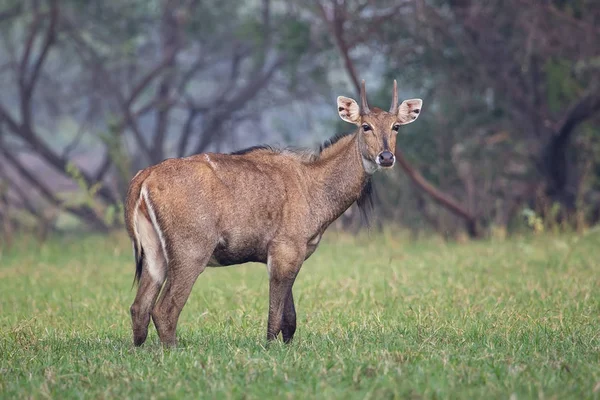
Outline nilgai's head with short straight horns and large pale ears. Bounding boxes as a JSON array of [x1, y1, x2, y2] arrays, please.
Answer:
[[337, 80, 423, 169]]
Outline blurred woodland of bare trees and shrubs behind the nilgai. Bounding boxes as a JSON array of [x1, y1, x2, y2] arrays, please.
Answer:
[[0, 0, 600, 243]]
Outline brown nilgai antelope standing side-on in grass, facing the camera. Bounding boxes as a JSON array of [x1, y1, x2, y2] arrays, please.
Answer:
[[125, 81, 422, 346]]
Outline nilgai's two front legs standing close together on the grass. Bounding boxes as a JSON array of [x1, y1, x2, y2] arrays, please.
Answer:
[[267, 242, 306, 343]]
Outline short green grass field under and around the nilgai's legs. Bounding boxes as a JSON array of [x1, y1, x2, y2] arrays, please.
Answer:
[[0, 233, 600, 399]]
